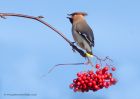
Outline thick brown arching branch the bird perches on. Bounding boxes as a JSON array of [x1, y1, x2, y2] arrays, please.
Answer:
[[0, 13, 86, 57]]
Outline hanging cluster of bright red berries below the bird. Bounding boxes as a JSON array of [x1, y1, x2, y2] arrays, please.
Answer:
[[70, 64, 117, 92]]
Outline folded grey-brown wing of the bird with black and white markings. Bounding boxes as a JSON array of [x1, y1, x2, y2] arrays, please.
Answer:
[[76, 21, 94, 47]]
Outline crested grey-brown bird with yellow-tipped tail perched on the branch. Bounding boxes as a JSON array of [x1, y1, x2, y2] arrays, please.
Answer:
[[67, 12, 94, 57]]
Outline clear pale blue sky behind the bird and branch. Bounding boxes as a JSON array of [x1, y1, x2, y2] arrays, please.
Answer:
[[0, 0, 140, 99]]
